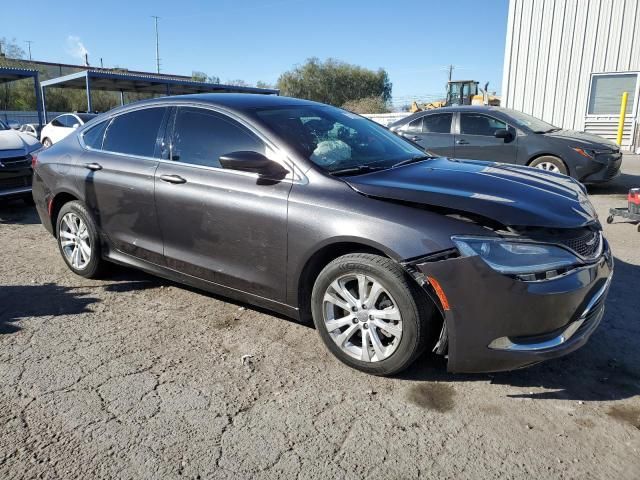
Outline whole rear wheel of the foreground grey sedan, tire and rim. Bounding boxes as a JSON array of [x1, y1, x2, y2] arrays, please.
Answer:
[[56, 201, 104, 278]]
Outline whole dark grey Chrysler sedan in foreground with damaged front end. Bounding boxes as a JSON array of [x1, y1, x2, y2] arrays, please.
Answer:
[[33, 94, 613, 375]]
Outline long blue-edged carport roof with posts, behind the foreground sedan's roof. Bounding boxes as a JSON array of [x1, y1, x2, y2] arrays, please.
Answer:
[[40, 70, 280, 120]]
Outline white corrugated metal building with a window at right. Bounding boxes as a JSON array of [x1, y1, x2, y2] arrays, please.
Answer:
[[501, 0, 640, 150]]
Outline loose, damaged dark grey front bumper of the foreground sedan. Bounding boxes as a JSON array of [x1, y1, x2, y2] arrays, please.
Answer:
[[411, 242, 613, 373]]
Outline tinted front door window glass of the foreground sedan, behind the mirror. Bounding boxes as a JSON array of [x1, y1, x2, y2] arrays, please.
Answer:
[[171, 108, 265, 167]]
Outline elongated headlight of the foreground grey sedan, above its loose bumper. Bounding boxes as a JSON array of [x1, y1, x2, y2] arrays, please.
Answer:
[[451, 236, 580, 280]]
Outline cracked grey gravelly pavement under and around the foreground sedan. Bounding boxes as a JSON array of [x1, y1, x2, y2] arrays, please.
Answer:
[[0, 157, 640, 479]]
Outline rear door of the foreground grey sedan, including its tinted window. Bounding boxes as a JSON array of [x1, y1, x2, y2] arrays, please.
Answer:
[[81, 107, 169, 265]]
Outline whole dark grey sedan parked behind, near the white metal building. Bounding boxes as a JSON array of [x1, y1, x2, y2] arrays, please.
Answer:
[[389, 106, 622, 183]]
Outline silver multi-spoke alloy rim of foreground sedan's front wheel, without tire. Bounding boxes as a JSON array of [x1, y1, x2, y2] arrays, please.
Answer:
[[323, 273, 402, 362]]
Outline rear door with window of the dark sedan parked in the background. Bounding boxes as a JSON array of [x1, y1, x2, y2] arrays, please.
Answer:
[[402, 113, 454, 157]]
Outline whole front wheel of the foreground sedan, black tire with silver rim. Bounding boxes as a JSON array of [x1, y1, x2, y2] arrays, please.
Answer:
[[311, 253, 437, 375]]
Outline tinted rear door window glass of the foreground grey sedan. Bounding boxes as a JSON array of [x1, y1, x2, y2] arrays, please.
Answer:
[[103, 107, 167, 157]]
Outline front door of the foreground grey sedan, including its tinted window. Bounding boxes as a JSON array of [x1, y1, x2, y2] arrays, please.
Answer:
[[155, 106, 292, 301]]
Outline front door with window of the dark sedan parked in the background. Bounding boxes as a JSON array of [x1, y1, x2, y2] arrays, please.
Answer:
[[455, 112, 517, 163]]
